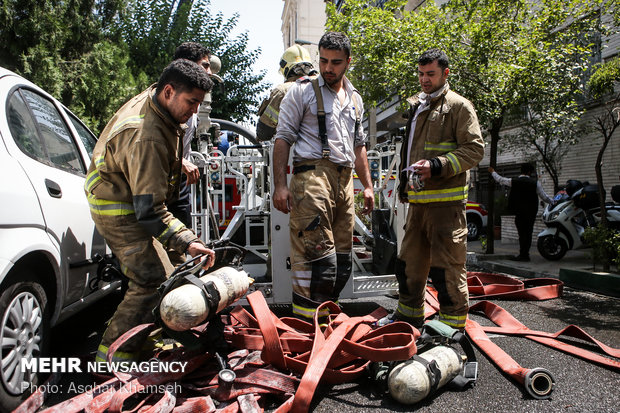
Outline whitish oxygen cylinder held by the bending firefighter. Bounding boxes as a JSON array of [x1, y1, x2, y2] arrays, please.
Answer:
[[159, 267, 253, 331]]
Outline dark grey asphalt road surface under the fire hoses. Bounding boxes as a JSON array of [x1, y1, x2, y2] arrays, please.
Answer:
[[46, 276, 620, 413]]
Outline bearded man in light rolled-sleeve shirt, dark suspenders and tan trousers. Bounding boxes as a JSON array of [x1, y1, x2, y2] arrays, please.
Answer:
[[273, 32, 374, 319]]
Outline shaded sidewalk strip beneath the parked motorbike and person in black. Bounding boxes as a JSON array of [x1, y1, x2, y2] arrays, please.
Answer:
[[467, 240, 600, 278]]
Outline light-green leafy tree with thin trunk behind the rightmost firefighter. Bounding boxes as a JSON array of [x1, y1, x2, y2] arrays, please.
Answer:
[[328, 0, 603, 253]]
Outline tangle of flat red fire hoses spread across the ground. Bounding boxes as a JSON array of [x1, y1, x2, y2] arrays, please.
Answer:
[[18, 273, 620, 413]]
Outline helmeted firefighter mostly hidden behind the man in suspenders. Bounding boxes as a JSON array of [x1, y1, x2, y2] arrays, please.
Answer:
[[256, 44, 317, 141]]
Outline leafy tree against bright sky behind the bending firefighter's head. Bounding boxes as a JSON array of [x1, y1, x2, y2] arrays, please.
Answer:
[[122, 0, 270, 121]]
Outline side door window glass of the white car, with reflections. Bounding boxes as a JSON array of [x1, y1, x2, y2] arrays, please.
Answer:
[[21, 89, 85, 173]]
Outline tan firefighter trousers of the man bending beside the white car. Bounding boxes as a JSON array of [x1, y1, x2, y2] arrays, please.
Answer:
[[91, 213, 174, 361]]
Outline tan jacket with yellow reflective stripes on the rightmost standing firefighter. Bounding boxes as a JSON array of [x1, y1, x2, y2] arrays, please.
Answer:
[[398, 83, 484, 205]]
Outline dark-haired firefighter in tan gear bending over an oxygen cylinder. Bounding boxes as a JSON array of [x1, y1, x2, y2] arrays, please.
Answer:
[[85, 59, 215, 361]]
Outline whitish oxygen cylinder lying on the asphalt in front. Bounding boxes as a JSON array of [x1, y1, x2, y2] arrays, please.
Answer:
[[388, 346, 463, 404]]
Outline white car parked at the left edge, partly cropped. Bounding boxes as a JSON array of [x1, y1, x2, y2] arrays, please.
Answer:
[[0, 67, 121, 411]]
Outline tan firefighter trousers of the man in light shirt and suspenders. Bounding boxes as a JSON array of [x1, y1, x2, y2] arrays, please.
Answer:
[[290, 159, 355, 319]]
